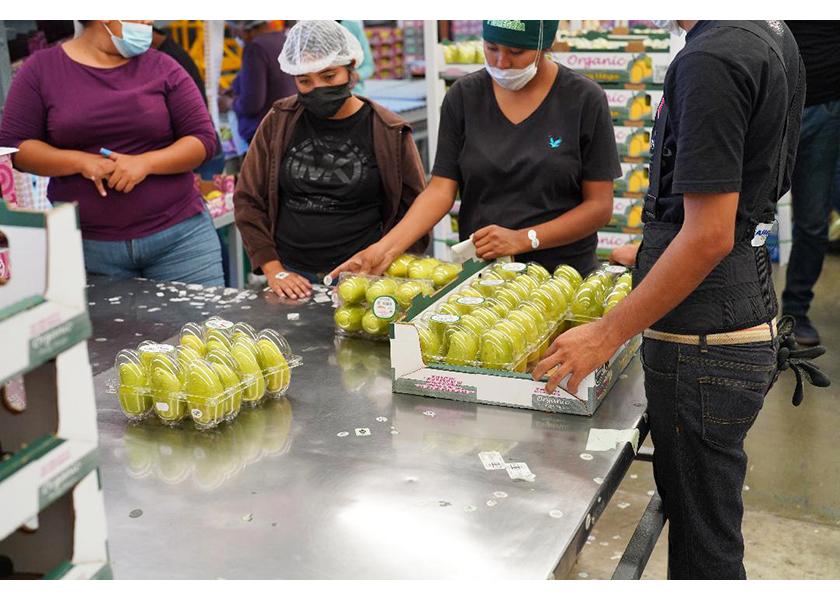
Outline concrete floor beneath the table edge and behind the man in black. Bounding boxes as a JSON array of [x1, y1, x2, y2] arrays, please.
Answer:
[[569, 255, 840, 579]]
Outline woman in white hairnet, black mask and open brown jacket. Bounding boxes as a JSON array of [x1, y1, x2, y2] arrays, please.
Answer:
[[234, 21, 428, 299]]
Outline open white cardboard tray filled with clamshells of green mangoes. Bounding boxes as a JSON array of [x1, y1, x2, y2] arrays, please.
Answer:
[[391, 260, 639, 415]]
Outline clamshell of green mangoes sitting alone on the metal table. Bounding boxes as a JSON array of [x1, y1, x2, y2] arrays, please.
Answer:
[[108, 317, 303, 429]]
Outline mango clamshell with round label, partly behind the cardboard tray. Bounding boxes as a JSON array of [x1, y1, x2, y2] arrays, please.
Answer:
[[334, 254, 461, 340]]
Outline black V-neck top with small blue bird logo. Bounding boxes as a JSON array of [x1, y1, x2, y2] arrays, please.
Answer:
[[432, 65, 621, 273]]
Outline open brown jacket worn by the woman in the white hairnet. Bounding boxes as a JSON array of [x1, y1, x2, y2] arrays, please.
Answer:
[[233, 96, 429, 272]]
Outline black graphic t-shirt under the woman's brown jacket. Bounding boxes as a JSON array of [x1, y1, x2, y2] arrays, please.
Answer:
[[276, 104, 384, 273]]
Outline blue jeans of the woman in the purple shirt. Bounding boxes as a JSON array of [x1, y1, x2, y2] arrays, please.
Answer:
[[83, 211, 225, 286]]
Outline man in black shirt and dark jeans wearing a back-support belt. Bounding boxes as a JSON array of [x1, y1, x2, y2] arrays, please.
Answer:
[[534, 21, 804, 579]]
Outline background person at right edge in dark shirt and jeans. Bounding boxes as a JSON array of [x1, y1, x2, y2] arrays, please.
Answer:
[[782, 21, 840, 346]]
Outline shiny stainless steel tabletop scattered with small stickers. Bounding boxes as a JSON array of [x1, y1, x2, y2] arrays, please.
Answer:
[[88, 278, 647, 579]]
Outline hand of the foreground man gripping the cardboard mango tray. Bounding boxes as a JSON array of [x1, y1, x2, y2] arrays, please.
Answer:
[[533, 321, 621, 394]]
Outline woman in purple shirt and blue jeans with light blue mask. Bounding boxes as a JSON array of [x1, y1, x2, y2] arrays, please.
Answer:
[[0, 21, 224, 285]]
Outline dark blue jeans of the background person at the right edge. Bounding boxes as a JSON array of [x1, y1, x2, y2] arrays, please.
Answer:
[[782, 100, 840, 317]]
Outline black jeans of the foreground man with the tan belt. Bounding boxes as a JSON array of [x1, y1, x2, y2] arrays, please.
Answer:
[[642, 339, 778, 579]]
